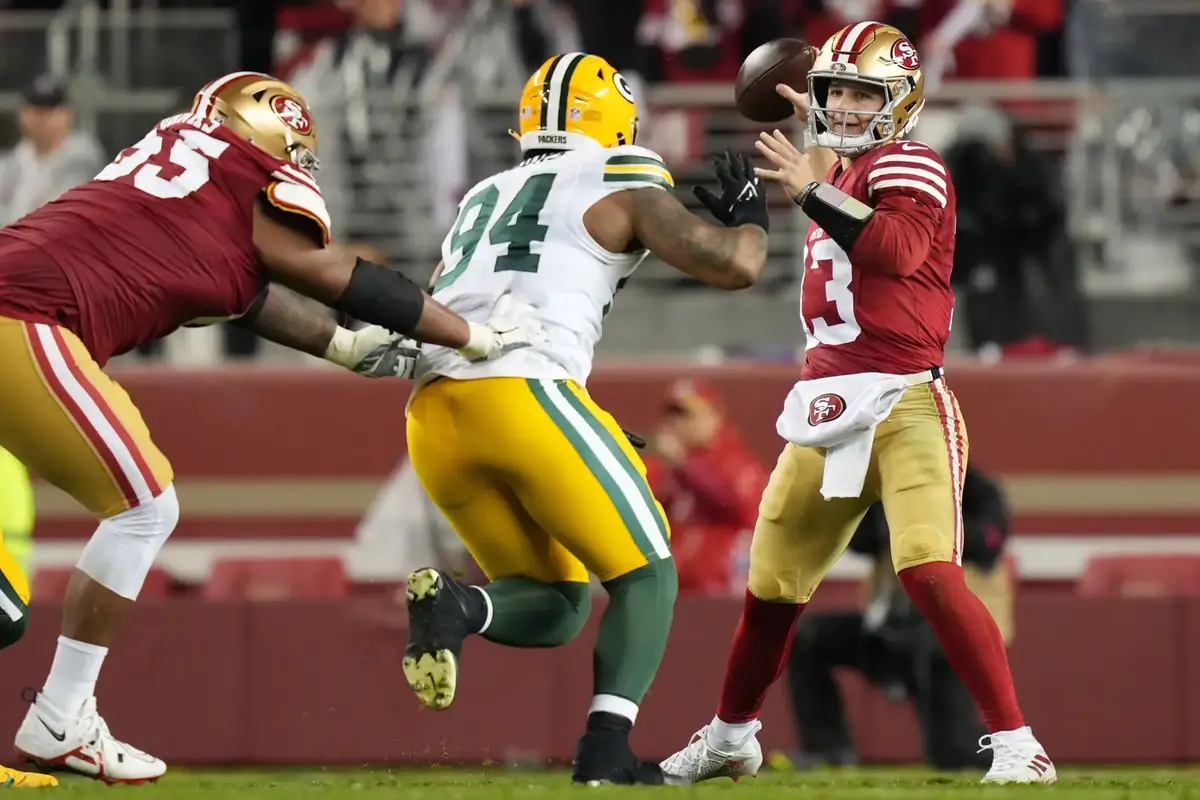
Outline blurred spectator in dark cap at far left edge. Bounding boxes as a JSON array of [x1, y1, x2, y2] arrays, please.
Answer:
[[0, 74, 107, 225]]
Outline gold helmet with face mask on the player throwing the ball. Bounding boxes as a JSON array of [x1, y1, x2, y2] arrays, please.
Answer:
[[809, 22, 925, 156]]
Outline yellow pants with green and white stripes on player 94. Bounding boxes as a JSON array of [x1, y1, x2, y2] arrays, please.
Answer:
[[408, 378, 671, 583]]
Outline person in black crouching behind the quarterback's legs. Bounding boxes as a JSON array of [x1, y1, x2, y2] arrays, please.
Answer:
[[787, 468, 1013, 770]]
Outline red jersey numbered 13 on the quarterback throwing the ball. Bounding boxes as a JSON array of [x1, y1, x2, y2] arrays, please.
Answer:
[[800, 142, 955, 380]]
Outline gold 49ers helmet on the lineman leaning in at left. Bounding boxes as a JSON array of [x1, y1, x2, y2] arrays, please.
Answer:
[[192, 72, 319, 172]]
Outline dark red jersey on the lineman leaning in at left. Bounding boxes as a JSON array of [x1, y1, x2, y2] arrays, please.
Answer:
[[0, 114, 329, 365]]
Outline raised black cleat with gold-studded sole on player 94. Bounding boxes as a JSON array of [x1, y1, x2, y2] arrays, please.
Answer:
[[403, 567, 470, 711]]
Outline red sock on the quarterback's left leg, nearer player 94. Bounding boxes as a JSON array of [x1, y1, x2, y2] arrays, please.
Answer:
[[716, 589, 804, 723]]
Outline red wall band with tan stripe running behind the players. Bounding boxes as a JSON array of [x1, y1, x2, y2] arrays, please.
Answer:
[[30, 359, 1200, 541]]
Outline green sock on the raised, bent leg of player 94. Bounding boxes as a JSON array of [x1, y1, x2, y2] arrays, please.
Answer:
[[482, 577, 592, 648]]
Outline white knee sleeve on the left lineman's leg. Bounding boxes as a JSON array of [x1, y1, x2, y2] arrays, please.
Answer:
[[76, 483, 179, 600]]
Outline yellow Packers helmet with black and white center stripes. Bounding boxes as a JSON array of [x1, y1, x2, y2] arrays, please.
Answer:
[[517, 53, 637, 152]]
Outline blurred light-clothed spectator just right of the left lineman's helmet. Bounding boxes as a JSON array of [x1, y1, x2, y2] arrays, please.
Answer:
[[281, 0, 467, 267]]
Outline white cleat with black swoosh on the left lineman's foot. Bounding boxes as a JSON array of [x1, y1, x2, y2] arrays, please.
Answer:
[[14, 692, 167, 783]]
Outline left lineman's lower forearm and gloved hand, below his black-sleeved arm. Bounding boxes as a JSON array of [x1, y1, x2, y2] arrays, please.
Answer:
[[233, 283, 421, 378]]
